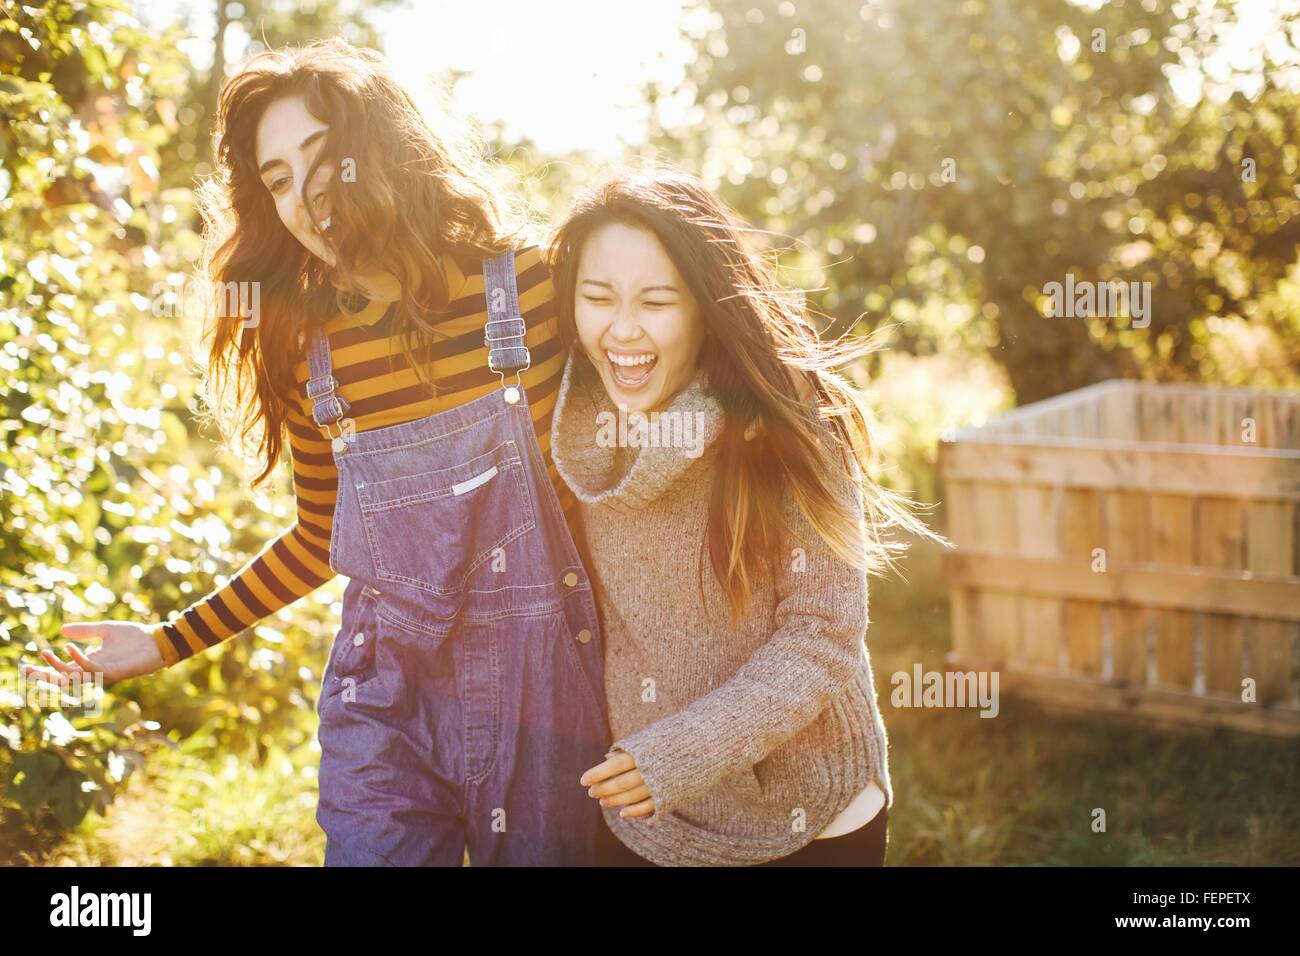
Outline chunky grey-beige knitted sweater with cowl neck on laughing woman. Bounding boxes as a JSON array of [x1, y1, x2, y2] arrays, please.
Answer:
[[551, 355, 893, 866]]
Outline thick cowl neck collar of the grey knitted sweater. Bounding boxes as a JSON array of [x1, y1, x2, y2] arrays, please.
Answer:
[[551, 352, 724, 511]]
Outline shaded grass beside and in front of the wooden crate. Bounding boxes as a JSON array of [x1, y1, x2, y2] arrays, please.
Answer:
[[867, 546, 1300, 866]]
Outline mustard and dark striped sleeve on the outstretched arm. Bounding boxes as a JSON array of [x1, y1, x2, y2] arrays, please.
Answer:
[[150, 395, 338, 666]]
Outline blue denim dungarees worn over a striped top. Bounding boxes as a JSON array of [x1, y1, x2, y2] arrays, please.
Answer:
[[307, 251, 611, 866]]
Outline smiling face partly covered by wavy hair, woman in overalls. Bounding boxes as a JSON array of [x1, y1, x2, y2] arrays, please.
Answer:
[[257, 96, 334, 265]]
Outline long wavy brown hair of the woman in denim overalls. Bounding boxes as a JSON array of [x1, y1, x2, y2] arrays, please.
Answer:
[[198, 39, 533, 486]]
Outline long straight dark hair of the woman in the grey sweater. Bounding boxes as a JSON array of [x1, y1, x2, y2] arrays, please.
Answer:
[[547, 166, 943, 622]]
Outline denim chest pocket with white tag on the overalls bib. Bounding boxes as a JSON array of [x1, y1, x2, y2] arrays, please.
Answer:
[[356, 440, 537, 594]]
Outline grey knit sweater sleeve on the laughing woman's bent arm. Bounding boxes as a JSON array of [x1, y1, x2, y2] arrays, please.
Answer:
[[610, 437, 867, 822]]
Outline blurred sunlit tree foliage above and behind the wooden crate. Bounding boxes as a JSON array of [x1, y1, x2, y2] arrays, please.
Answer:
[[653, 0, 1300, 403]]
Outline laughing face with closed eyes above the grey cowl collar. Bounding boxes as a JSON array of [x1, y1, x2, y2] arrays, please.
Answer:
[[573, 222, 706, 412]]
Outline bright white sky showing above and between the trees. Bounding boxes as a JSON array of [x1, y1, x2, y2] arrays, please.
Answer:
[[138, 0, 1300, 155]]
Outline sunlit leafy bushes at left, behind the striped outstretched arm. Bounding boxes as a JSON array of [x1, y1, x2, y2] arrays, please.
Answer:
[[0, 3, 338, 852]]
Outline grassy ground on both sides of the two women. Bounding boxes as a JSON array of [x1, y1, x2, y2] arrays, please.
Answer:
[[35, 546, 1300, 866]]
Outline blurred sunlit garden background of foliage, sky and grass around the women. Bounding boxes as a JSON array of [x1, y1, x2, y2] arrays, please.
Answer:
[[0, 0, 1300, 865]]
